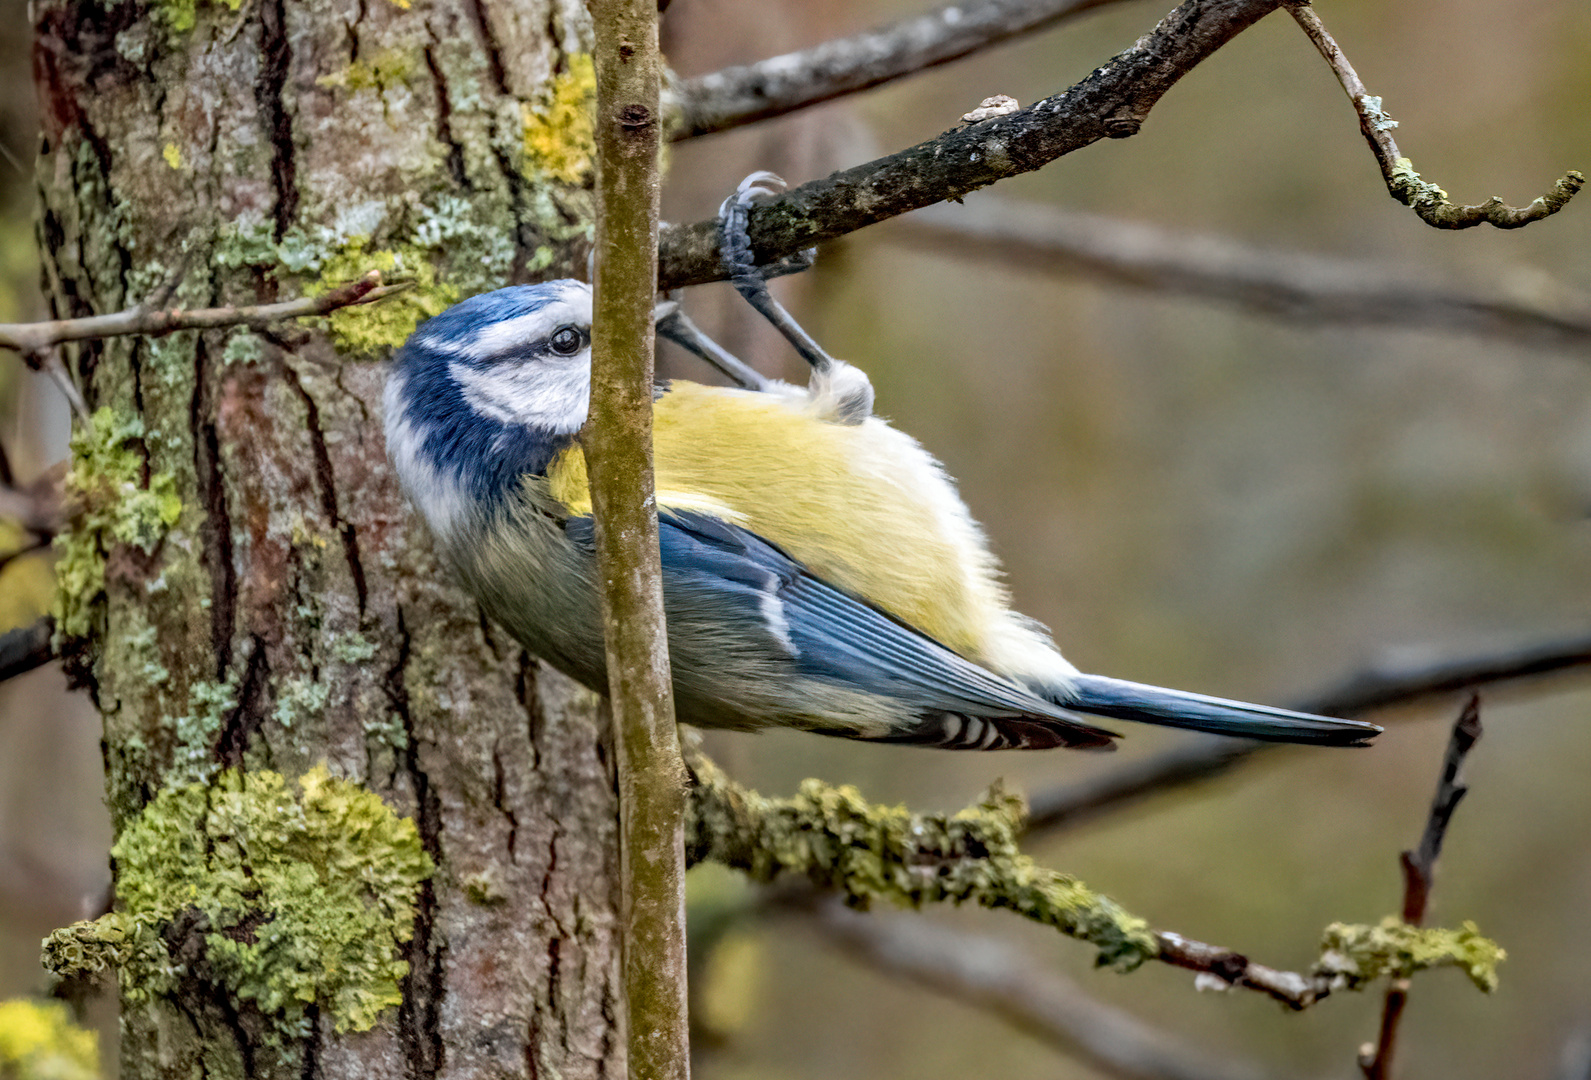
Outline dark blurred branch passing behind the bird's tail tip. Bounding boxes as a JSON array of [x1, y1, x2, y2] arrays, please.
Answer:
[[1028, 633, 1591, 833]]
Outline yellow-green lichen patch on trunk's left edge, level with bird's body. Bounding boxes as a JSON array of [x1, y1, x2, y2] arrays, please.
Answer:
[[54, 407, 183, 639]]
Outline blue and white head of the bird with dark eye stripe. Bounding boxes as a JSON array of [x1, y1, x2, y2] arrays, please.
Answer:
[[385, 280, 592, 534]]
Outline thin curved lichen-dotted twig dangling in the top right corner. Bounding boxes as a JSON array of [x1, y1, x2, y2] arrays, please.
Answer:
[[1286, 0, 1586, 229]]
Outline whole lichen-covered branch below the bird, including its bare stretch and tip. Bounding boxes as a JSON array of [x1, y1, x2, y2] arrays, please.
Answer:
[[686, 748, 1503, 1008]]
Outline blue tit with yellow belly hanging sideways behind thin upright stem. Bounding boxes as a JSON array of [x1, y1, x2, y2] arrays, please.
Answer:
[[385, 280, 1381, 749]]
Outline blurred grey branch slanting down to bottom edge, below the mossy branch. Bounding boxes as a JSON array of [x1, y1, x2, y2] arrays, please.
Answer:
[[802, 891, 1265, 1080]]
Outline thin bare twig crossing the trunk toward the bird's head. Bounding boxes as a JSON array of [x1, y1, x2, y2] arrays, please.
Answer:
[[0, 270, 409, 356]]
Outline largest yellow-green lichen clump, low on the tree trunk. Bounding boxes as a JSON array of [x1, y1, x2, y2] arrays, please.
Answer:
[[45, 767, 433, 1037]]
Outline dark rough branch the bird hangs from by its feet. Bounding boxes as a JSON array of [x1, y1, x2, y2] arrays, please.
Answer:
[[659, 0, 1281, 291]]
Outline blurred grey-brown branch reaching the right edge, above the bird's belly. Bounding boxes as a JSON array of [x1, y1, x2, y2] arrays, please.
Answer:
[[888, 196, 1591, 350]]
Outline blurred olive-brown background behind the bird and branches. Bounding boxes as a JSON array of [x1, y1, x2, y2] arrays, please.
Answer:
[[9, 0, 1591, 1080]]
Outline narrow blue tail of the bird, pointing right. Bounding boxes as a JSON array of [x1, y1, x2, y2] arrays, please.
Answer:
[[1060, 674, 1381, 746]]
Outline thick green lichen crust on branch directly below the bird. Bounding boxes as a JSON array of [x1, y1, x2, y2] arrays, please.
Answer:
[[686, 754, 1160, 970]]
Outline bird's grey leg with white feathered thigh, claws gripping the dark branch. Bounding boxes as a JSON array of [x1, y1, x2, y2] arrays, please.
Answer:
[[718, 172, 873, 425]]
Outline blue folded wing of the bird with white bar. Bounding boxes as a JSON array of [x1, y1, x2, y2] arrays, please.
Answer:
[[568, 511, 1112, 749]]
